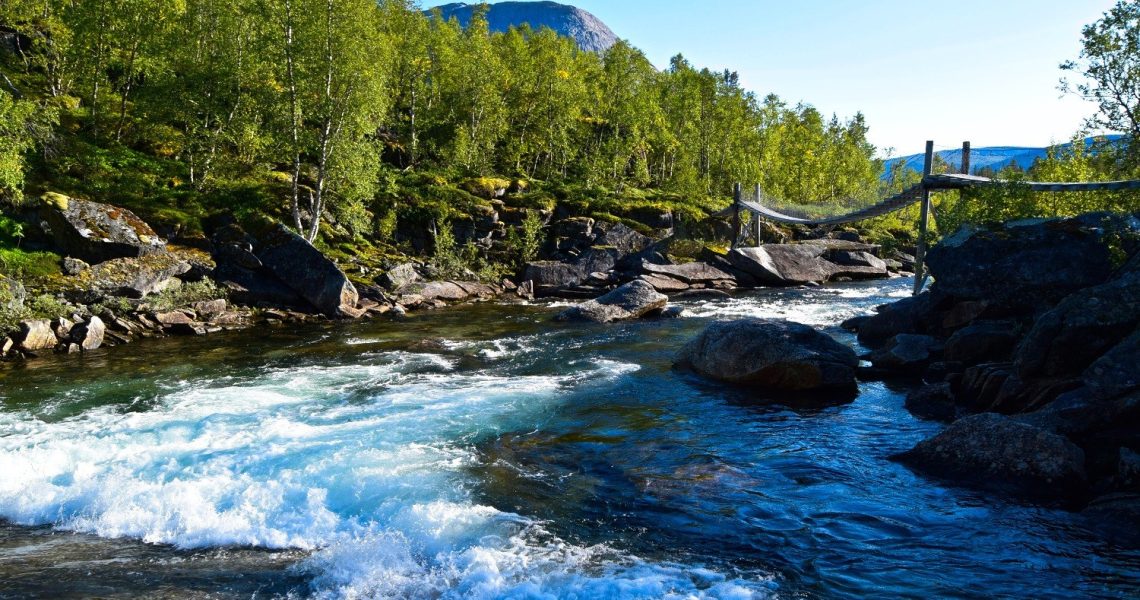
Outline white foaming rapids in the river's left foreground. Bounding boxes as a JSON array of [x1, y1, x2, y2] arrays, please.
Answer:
[[0, 351, 771, 598]]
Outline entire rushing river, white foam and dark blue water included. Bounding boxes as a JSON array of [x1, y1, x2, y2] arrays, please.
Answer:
[[0, 279, 1140, 599]]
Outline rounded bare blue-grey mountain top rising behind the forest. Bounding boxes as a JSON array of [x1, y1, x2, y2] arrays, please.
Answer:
[[430, 2, 618, 52]]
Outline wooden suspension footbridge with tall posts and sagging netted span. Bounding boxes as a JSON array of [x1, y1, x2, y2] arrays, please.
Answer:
[[731, 141, 1140, 294]]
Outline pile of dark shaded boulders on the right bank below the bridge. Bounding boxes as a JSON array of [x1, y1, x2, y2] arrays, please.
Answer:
[[845, 213, 1140, 519]]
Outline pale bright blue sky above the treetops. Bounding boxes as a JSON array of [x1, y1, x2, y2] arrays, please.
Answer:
[[423, 0, 1114, 155]]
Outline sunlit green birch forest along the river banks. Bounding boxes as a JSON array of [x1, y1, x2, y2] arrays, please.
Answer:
[[0, 0, 1137, 277]]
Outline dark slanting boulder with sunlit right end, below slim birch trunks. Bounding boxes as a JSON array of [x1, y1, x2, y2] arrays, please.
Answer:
[[258, 224, 359, 317]]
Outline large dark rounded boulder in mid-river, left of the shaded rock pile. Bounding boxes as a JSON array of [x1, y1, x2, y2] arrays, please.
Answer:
[[675, 318, 858, 392]]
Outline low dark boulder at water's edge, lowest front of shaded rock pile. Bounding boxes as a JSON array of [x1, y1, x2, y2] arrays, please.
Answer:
[[896, 413, 1085, 497]]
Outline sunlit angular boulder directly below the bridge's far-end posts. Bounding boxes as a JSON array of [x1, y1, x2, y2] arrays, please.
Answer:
[[726, 244, 836, 285]]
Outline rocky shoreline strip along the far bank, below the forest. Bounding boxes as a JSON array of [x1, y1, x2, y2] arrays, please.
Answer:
[[0, 194, 913, 360]]
